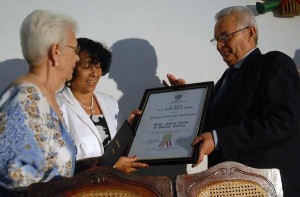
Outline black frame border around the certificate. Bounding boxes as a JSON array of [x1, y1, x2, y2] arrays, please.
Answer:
[[125, 81, 214, 165]]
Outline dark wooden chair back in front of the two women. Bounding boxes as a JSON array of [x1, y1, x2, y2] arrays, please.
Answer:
[[28, 167, 173, 197]]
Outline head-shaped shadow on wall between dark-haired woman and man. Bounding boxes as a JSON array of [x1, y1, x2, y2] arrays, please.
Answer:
[[108, 38, 162, 121]]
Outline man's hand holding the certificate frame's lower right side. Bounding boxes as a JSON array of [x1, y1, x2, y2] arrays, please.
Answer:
[[192, 132, 215, 167]]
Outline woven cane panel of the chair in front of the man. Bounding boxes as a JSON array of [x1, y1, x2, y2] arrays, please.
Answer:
[[197, 180, 268, 197]]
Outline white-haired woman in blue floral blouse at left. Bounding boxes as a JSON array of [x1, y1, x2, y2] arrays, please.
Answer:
[[0, 10, 79, 196]]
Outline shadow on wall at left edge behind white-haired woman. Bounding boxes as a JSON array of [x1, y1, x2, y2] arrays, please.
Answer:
[[0, 59, 28, 94]]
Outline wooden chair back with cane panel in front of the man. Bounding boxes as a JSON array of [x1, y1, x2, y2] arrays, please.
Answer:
[[176, 161, 283, 197]]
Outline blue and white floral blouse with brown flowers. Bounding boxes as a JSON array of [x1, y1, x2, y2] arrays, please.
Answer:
[[0, 83, 76, 189]]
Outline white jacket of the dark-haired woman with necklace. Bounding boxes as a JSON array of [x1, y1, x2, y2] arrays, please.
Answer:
[[56, 87, 119, 160]]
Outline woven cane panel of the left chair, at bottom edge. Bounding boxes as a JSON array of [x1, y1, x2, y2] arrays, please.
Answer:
[[71, 190, 142, 197]]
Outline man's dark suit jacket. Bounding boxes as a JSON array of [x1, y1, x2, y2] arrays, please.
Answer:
[[206, 49, 300, 196]]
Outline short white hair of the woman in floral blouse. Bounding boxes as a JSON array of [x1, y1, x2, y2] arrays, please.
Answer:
[[20, 10, 77, 66]]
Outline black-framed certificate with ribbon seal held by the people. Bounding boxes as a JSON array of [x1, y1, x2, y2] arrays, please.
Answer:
[[127, 82, 214, 165]]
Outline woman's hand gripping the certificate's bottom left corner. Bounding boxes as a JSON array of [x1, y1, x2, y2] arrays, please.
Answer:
[[114, 156, 149, 173]]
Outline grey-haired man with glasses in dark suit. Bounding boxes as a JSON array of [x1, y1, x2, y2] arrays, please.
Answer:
[[167, 6, 300, 196]]
